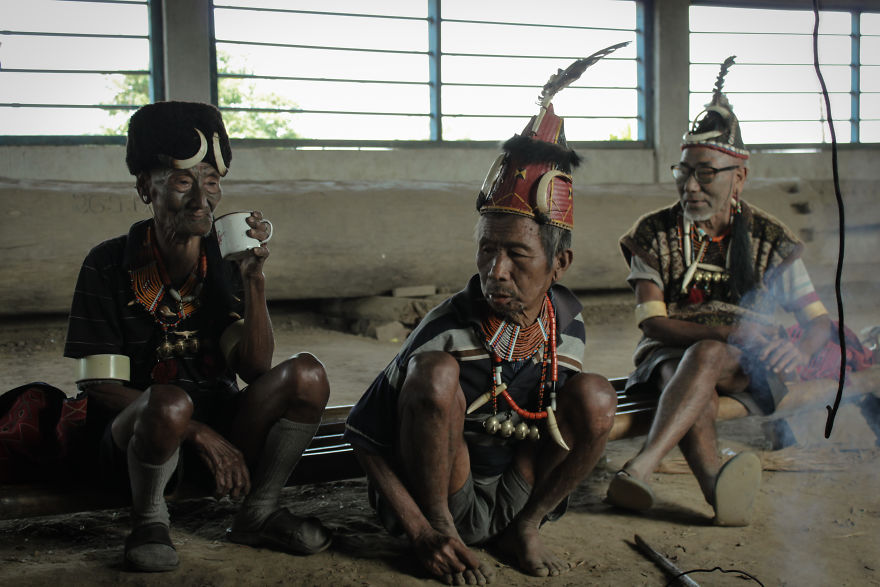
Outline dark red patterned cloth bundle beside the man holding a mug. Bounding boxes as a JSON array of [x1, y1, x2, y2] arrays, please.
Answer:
[[0, 383, 87, 483]]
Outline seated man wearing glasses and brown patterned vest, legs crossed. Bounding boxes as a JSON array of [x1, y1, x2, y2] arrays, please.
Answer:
[[608, 58, 831, 526]]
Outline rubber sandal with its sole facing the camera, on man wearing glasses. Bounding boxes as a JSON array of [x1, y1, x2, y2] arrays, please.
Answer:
[[713, 452, 761, 526]]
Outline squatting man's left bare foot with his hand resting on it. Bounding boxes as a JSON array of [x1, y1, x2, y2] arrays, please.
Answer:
[[413, 528, 495, 585]]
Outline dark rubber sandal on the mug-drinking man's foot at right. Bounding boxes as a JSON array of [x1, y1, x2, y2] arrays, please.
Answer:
[[226, 508, 333, 555]]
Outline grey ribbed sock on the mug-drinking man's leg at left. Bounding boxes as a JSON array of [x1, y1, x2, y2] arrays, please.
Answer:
[[126, 442, 180, 528]]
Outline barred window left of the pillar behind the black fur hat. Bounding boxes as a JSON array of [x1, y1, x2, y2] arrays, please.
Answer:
[[0, 0, 151, 136]]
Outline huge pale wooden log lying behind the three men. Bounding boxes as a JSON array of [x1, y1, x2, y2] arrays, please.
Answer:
[[0, 170, 880, 314]]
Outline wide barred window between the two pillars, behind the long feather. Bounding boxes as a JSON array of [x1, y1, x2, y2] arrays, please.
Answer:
[[214, 0, 646, 142]]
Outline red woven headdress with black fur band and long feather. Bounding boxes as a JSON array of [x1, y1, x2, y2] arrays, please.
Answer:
[[477, 42, 629, 230]]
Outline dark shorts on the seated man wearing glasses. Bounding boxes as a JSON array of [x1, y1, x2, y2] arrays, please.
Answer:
[[626, 347, 788, 415]]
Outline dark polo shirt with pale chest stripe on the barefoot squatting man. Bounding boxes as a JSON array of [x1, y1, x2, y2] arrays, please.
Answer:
[[345, 275, 585, 476]]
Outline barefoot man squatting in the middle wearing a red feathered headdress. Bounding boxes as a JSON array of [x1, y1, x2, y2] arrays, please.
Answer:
[[345, 43, 616, 585]]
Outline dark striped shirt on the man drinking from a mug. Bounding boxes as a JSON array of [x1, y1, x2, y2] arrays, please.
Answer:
[[64, 220, 243, 391]]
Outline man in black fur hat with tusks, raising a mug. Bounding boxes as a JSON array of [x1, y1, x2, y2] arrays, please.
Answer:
[[64, 102, 330, 571]]
